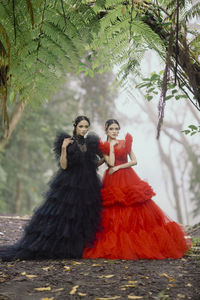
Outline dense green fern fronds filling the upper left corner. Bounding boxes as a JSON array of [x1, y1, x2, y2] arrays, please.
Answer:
[[0, 0, 98, 120]]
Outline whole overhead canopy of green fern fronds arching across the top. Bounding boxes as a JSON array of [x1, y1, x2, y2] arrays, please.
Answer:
[[0, 0, 200, 142]]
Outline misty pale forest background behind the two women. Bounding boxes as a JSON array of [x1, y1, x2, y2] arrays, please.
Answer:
[[0, 51, 200, 225]]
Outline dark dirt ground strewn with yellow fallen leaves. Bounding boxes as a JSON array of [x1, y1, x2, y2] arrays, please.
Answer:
[[0, 216, 200, 300]]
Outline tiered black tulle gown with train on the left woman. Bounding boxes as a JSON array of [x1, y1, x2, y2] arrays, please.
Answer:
[[0, 133, 101, 261]]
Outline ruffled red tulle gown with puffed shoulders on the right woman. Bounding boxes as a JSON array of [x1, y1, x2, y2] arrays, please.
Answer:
[[83, 134, 191, 260]]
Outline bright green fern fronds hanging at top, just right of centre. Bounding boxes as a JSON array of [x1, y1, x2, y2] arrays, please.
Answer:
[[90, 1, 165, 80]]
